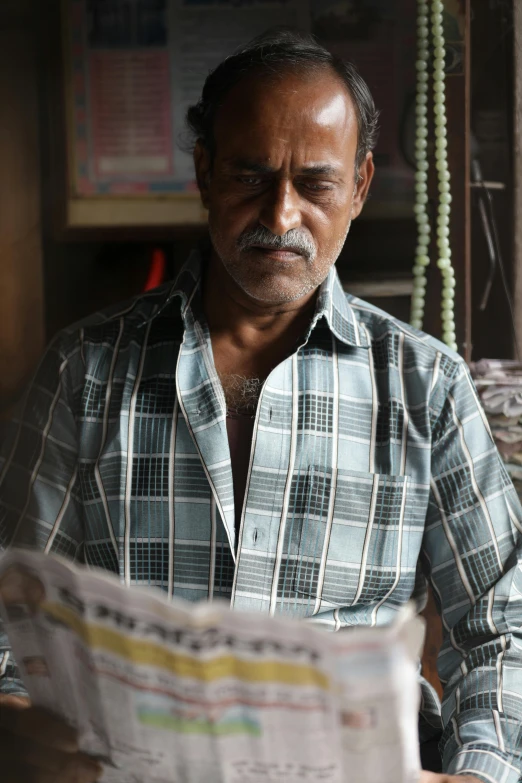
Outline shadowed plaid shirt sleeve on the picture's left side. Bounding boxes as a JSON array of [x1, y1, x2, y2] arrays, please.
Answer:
[[0, 334, 83, 694]]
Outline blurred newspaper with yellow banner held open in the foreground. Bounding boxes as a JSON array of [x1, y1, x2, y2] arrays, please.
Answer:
[[0, 550, 424, 783]]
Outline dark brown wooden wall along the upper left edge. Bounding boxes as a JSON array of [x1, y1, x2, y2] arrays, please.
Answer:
[[0, 0, 44, 411]]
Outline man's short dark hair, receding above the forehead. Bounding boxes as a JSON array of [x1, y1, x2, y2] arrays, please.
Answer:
[[186, 28, 379, 169]]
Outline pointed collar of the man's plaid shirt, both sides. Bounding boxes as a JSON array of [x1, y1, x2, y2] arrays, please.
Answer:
[[149, 250, 369, 348]]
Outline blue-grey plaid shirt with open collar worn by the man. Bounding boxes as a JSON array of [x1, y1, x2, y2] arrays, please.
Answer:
[[0, 253, 522, 783]]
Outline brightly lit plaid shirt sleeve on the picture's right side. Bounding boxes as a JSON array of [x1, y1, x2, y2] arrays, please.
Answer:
[[423, 366, 522, 783]]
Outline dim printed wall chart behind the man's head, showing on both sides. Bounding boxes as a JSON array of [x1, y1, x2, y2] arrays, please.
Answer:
[[65, 0, 415, 225]]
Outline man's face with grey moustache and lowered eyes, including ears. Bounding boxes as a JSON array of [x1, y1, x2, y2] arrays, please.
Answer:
[[194, 70, 373, 304]]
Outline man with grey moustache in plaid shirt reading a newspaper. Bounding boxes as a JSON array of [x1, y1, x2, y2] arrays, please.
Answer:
[[0, 27, 522, 783]]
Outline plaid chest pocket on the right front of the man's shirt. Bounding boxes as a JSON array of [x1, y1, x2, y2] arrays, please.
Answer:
[[294, 466, 408, 608]]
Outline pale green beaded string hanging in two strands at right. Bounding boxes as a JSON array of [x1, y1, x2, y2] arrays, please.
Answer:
[[411, 0, 457, 351]]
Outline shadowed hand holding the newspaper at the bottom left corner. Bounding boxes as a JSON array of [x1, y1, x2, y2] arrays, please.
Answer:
[[0, 695, 102, 783]]
